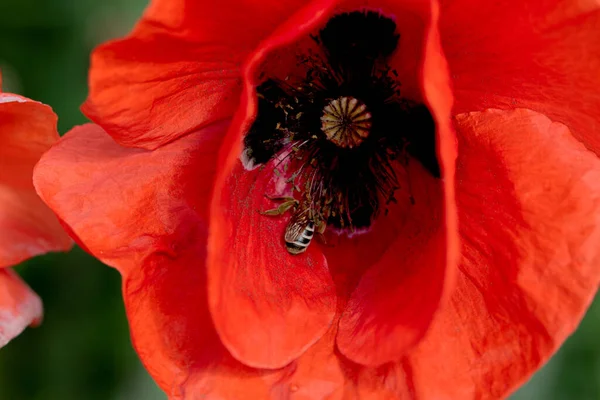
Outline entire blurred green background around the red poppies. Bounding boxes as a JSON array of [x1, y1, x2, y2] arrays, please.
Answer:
[[0, 0, 600, 400]]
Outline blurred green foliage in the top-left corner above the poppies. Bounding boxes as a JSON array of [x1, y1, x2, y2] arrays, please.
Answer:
[[0, 0, 146, 133]]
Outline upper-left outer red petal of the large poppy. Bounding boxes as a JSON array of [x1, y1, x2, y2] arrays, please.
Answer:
[[83, 0, 326, 149]]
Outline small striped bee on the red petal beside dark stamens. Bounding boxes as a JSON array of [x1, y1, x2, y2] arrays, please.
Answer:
[[261, 196, 327, 255]]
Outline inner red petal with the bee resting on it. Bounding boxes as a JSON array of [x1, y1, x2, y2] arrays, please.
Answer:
[[208, 161, 336, 368]]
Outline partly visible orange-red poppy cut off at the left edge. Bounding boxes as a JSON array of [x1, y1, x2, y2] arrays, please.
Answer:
[[0, 73, 71, 347]]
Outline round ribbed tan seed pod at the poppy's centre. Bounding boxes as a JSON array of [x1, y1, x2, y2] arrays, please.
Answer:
[[321, 96, 371, 148]]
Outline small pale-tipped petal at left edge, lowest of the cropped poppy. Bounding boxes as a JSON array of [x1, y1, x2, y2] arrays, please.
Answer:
[[0, 269, 42, 347]]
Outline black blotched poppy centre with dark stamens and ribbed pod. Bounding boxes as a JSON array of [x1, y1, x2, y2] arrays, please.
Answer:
[[244, 12, 440, 232]]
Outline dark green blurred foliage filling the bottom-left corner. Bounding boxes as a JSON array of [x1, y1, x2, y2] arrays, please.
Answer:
[[0, 248, 164, 400]]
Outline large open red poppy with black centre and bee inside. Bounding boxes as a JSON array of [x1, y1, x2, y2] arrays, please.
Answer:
[[35, 0, 600, 399]]
